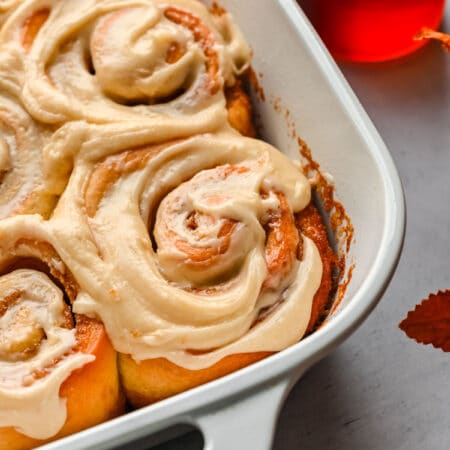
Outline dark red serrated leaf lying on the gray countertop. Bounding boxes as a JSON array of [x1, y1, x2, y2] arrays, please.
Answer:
[[399, 290, 450, 352]]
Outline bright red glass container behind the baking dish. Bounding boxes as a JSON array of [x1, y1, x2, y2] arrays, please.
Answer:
[[298, 0, 445, 61]]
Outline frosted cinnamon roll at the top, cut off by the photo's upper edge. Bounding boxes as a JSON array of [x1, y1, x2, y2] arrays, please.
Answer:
[[0, 0, 251, 137]]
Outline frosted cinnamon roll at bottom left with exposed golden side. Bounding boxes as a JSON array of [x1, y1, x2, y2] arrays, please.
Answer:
[[0, 216, 123, 449]]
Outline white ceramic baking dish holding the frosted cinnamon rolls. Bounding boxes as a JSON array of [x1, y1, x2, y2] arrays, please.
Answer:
[[37, 0, 405, 450]]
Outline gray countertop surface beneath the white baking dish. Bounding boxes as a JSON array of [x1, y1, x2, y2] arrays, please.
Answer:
[[150, 5, 450, 450]]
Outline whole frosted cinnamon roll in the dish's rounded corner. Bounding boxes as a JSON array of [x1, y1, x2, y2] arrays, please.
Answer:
[[52, 133, 331, 405]]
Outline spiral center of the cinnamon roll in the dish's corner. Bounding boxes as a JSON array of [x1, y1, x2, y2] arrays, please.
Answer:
[[154, 165, 255, 286]]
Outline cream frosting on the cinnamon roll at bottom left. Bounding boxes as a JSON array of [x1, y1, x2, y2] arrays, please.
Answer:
[[0, 216, 94, 439]]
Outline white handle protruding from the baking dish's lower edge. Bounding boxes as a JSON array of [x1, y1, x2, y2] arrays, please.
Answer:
[[194, 378, 292, 450]]
